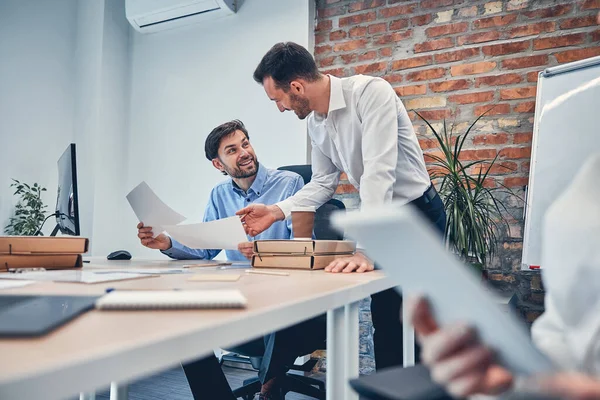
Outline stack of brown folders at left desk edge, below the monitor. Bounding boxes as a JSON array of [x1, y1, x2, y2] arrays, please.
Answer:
[[0, 236, 89, 272]]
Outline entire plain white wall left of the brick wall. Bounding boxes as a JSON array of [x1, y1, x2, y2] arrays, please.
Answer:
[[0, 0, 314, 257]]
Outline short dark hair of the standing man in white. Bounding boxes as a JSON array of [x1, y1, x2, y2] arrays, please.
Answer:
[[254, 42, 320, 92]]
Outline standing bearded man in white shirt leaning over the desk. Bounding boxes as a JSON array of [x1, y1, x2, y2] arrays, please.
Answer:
[[238, 42, 446, 369]]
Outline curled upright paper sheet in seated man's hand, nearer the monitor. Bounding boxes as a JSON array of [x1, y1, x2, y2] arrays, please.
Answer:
[[127, 182, 186, 237]]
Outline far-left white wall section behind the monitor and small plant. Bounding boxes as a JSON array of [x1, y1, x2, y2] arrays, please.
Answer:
[[0, 0, 77, 233]]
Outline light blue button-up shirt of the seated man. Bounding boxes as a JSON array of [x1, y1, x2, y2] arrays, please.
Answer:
[[163, 164, 304, 261]]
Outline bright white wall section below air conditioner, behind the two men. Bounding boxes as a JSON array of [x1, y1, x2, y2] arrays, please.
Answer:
[[126, 0, 314, 255]]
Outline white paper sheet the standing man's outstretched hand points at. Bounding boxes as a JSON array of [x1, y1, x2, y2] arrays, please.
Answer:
[[163, 216, 248, 250]]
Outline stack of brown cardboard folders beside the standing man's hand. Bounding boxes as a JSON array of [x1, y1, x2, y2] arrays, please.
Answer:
[[252, 240, 356, 270]]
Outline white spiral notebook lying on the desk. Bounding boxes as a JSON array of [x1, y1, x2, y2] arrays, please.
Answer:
[[96, 290, 247, 310]]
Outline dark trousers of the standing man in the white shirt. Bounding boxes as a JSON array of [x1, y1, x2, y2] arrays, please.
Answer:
[[371, 186, 446, 370]]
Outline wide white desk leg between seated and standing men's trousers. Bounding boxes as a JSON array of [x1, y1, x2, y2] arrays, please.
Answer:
[[325, 307, 347, 400]]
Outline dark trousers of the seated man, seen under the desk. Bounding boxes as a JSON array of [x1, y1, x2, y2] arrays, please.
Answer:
[[183, 315, 327, 400]]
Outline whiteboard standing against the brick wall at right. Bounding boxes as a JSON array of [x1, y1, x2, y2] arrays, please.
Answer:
[[522, 57, 600, 269]]
